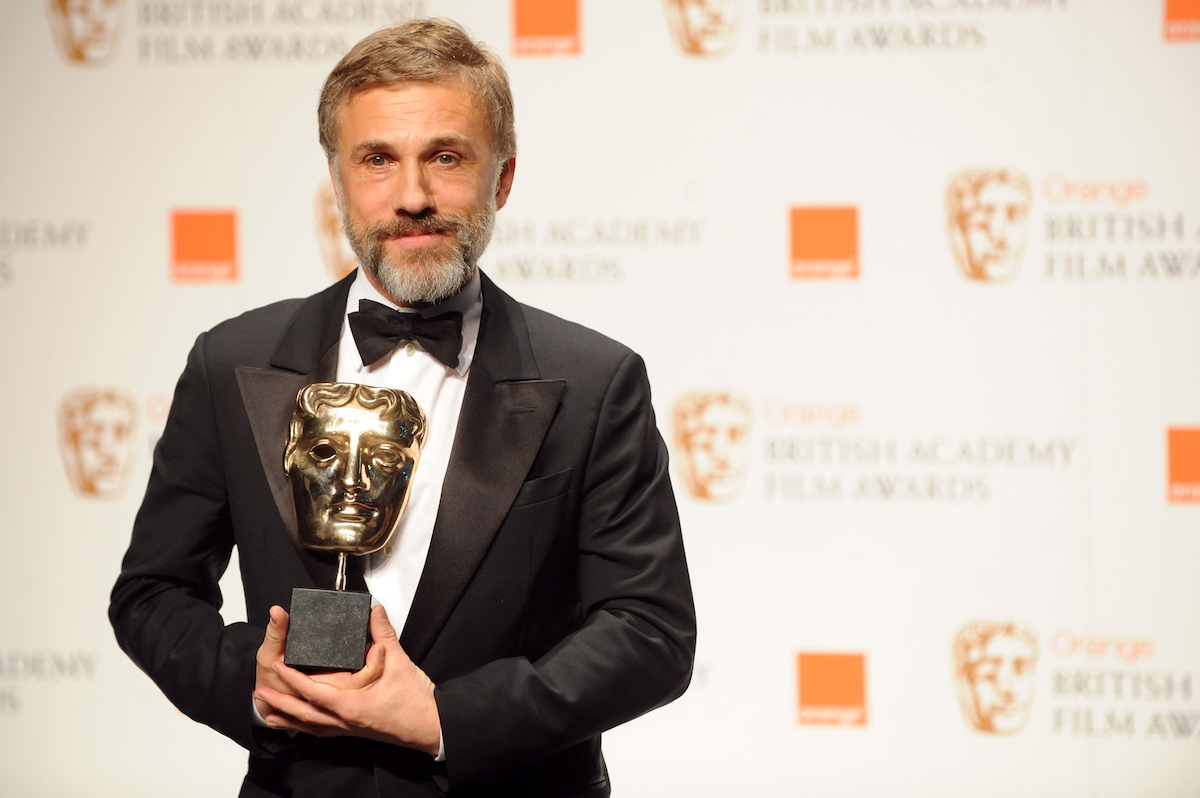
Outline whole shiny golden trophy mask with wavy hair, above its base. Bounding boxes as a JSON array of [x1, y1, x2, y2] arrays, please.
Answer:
[[283, 383, 426, 554]]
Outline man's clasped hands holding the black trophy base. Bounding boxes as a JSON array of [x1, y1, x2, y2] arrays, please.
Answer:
[[254, 606, 442, 755]]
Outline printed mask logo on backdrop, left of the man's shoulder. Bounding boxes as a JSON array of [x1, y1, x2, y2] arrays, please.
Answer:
[[59, 388, 137, 499]]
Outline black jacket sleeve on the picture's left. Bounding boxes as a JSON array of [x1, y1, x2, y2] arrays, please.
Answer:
[[109, 335, 274, 751]]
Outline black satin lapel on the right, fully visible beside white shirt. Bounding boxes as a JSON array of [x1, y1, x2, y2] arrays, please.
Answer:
[[400, 277, 565, 662]]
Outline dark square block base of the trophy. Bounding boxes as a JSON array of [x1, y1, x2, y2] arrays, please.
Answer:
[[283, 588, 371, 673]]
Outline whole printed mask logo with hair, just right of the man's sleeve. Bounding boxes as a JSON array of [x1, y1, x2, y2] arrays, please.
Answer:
[[673, 392, 750, 502]]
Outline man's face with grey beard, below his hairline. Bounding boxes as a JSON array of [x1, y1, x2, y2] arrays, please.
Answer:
[[330, 80, 516, 306]]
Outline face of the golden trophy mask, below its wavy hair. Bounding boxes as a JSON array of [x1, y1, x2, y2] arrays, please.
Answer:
[[287, 406, 419, 554]]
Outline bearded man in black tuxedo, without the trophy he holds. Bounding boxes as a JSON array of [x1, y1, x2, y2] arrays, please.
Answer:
[[109, 20, 695, 798]]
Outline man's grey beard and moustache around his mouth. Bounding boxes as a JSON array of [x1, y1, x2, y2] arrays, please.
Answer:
[[342, 199, 496, 305]]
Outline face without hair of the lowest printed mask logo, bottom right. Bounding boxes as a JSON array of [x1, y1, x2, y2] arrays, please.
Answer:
[[967, 635, 1037, 734]]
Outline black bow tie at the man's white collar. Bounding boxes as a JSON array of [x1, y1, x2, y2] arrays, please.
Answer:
[[348, 299, 462, 368]]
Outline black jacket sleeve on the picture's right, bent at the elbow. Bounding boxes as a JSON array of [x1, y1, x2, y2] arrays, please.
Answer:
[[434, 353, 696, 786]]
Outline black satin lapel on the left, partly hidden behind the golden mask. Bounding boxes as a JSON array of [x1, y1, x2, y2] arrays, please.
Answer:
[[234, 274, 366, 590]]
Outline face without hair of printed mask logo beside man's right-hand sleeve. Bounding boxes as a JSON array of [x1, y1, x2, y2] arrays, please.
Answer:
[[684, 402, 749, 500]]
